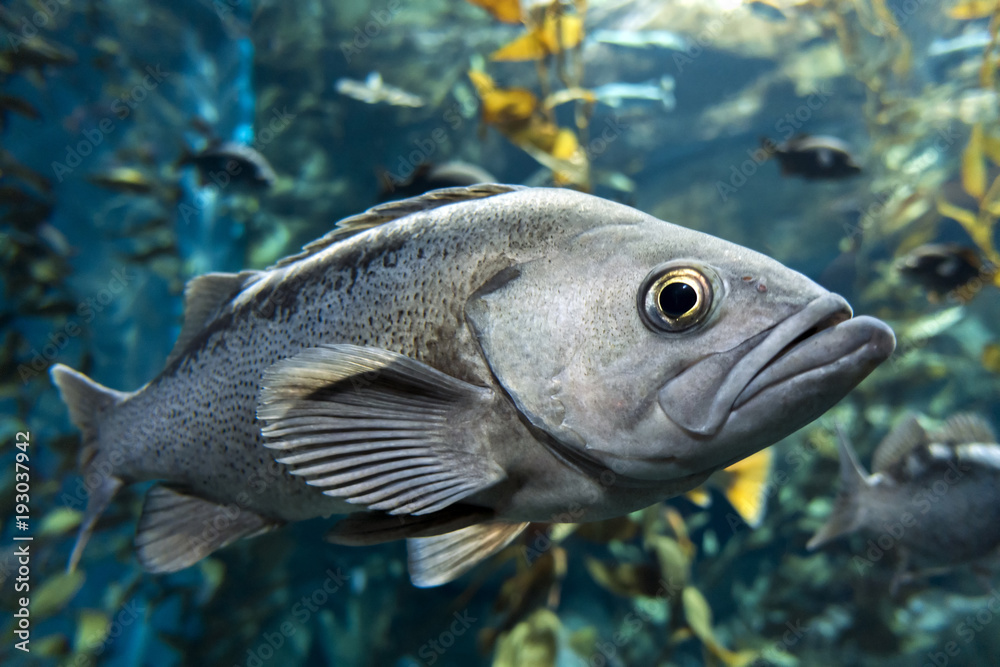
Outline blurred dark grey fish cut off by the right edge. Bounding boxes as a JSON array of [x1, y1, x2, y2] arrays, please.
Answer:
[[809, 414, 1000, 573]]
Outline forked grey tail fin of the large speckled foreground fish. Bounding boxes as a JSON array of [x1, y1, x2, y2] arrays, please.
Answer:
[[49, 364, 129, 571]]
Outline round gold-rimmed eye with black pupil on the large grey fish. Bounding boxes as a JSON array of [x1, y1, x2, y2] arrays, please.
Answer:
[[639, 264, 714, 333]]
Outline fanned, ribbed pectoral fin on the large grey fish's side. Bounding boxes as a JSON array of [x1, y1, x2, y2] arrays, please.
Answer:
[[257, 345, 506, 514]]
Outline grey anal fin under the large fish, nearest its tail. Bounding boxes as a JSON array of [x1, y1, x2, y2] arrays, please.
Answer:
[[135, 484, 281, 573]]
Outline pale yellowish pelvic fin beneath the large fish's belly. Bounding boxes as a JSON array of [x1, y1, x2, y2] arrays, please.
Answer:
[[406, 523, 528, 588]]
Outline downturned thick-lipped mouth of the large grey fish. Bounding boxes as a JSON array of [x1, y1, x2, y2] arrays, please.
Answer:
[[658, 293, 895, 435]]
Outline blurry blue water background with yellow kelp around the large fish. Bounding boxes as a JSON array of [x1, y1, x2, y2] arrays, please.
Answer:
[[0, 0, 1000, 667]]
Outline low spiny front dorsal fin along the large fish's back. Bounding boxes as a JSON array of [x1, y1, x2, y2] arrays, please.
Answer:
[[270, 183, 523, 269]]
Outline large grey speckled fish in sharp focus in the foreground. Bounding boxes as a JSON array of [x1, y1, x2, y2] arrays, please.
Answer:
[[52, 185, 895, 586]]
